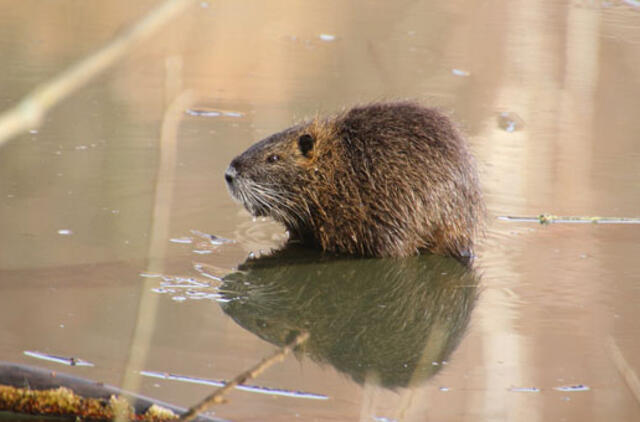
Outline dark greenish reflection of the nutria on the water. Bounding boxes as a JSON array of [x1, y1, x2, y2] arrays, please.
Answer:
[[221, 247, 478, 388]]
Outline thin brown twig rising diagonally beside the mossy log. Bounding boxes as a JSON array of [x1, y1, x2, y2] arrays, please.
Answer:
[[179, 333, 309, 422]]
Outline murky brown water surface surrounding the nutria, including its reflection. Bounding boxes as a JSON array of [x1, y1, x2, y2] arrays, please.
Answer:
[[0, 0, 640, 421]]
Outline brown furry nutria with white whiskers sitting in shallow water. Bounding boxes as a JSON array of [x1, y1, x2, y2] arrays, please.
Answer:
[[225, 102, 484, 257]]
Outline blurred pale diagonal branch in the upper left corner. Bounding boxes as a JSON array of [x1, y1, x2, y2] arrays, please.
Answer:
[[0, 0, 194, 147]]
